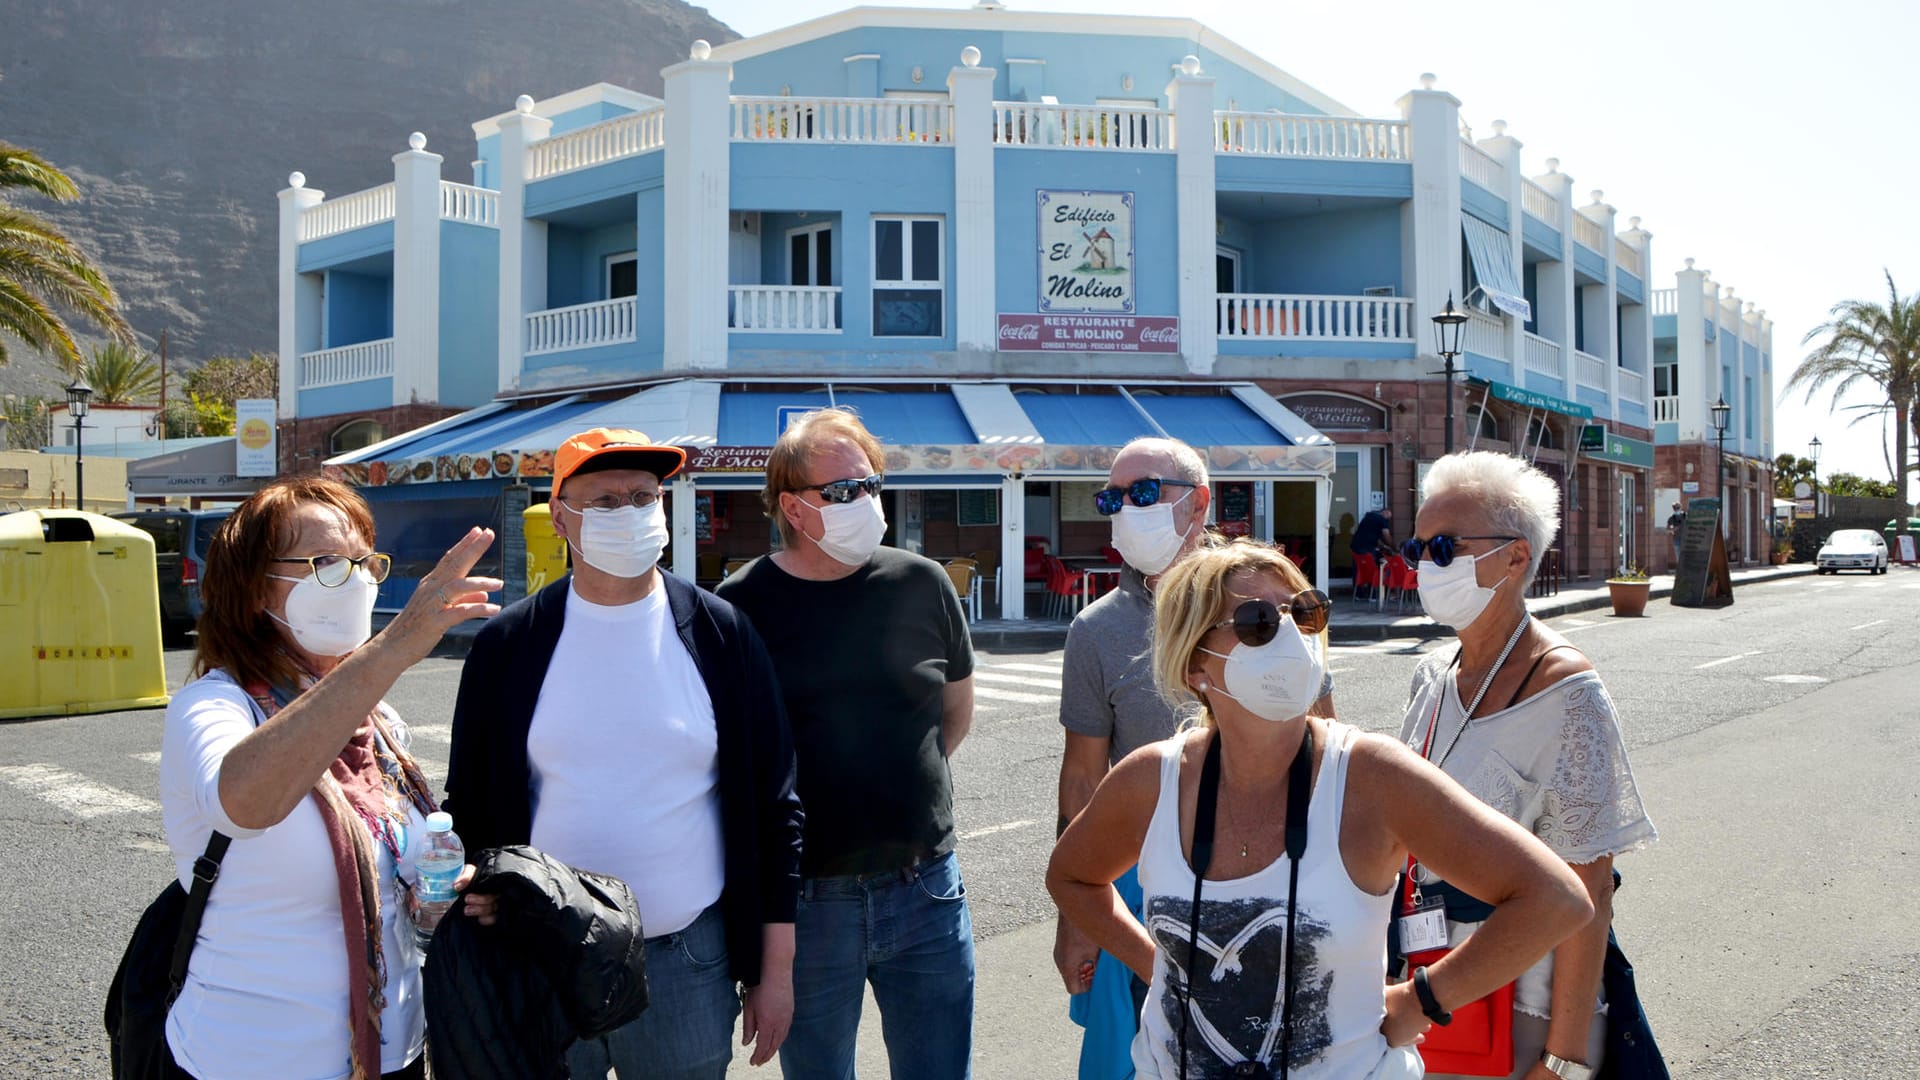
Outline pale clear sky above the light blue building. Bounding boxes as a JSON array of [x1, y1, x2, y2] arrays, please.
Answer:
[[707, 0, 1920, 484]]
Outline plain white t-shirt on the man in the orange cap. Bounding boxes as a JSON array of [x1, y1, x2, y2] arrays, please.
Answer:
[[526, 586, 726, 938]]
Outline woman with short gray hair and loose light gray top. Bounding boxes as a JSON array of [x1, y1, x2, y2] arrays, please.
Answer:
[[1400, 452, 1655, 1080]]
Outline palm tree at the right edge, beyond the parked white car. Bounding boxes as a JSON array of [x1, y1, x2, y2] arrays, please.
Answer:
[[1786, 271, 1920, 502]]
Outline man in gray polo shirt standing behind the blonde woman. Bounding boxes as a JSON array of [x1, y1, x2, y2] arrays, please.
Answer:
[[1054, 438, 1332, 1080]]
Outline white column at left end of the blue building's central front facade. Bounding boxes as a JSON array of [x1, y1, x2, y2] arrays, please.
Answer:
[[660, 40, 733, 371]]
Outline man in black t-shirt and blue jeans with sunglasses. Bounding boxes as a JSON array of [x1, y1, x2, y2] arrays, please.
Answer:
[[718, 409, 973, 1080]]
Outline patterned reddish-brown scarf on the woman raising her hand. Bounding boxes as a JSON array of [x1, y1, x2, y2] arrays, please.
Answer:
[[248, 675, 438, 1080]]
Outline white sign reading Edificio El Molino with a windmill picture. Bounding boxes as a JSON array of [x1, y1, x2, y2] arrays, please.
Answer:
[[1037, 190, 1137, 315]]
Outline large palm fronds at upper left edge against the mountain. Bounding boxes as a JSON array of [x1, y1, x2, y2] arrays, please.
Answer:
[[0, 142, 132, 369]]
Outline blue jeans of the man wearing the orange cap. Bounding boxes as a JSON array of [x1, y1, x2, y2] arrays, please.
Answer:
[[566, 903, 739, 1080]]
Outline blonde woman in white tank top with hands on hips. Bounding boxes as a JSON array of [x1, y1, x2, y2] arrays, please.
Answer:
[[1046, 542, 1592, 1080]]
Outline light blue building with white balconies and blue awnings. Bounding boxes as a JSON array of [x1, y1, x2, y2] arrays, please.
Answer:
[[280, 4, 1770, 619]]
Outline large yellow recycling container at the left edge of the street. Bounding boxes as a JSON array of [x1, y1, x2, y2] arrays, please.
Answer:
[[0, 509, 167, 717]]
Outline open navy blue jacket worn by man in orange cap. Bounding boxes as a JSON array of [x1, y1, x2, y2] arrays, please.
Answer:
[[445, 571, 803, 986]]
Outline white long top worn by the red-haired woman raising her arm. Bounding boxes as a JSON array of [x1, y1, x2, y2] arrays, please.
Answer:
[[159, 671, 426, 1080]]
